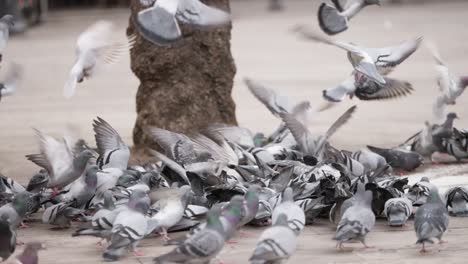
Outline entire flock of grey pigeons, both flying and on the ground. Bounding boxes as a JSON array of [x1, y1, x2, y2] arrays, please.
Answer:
[[0, 0, 468, 264]]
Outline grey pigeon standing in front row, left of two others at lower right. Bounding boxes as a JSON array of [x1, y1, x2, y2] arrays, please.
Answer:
[[335, 191, 375, 249]]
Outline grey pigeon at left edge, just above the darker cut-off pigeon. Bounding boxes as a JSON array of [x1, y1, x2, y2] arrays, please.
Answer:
[[0, 192, 31, 229]]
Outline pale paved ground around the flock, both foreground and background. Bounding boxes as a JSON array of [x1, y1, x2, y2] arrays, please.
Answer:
[[0, 1, 468, 264]]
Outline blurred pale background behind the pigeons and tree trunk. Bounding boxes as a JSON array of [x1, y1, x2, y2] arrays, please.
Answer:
[[0, 0, 468, 182]]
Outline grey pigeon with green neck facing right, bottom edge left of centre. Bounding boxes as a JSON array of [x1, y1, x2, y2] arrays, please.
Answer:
[[153, 208, 226, 264]]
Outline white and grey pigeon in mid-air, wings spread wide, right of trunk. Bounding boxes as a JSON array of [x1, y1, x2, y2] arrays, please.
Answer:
[[295, 26, 422, 103]]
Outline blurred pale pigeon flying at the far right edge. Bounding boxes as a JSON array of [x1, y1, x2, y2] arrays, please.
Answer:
[[428, 44, 468, 123]]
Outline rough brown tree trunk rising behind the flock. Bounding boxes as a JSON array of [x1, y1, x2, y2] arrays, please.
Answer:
[[127, 0, 236, 153]]
